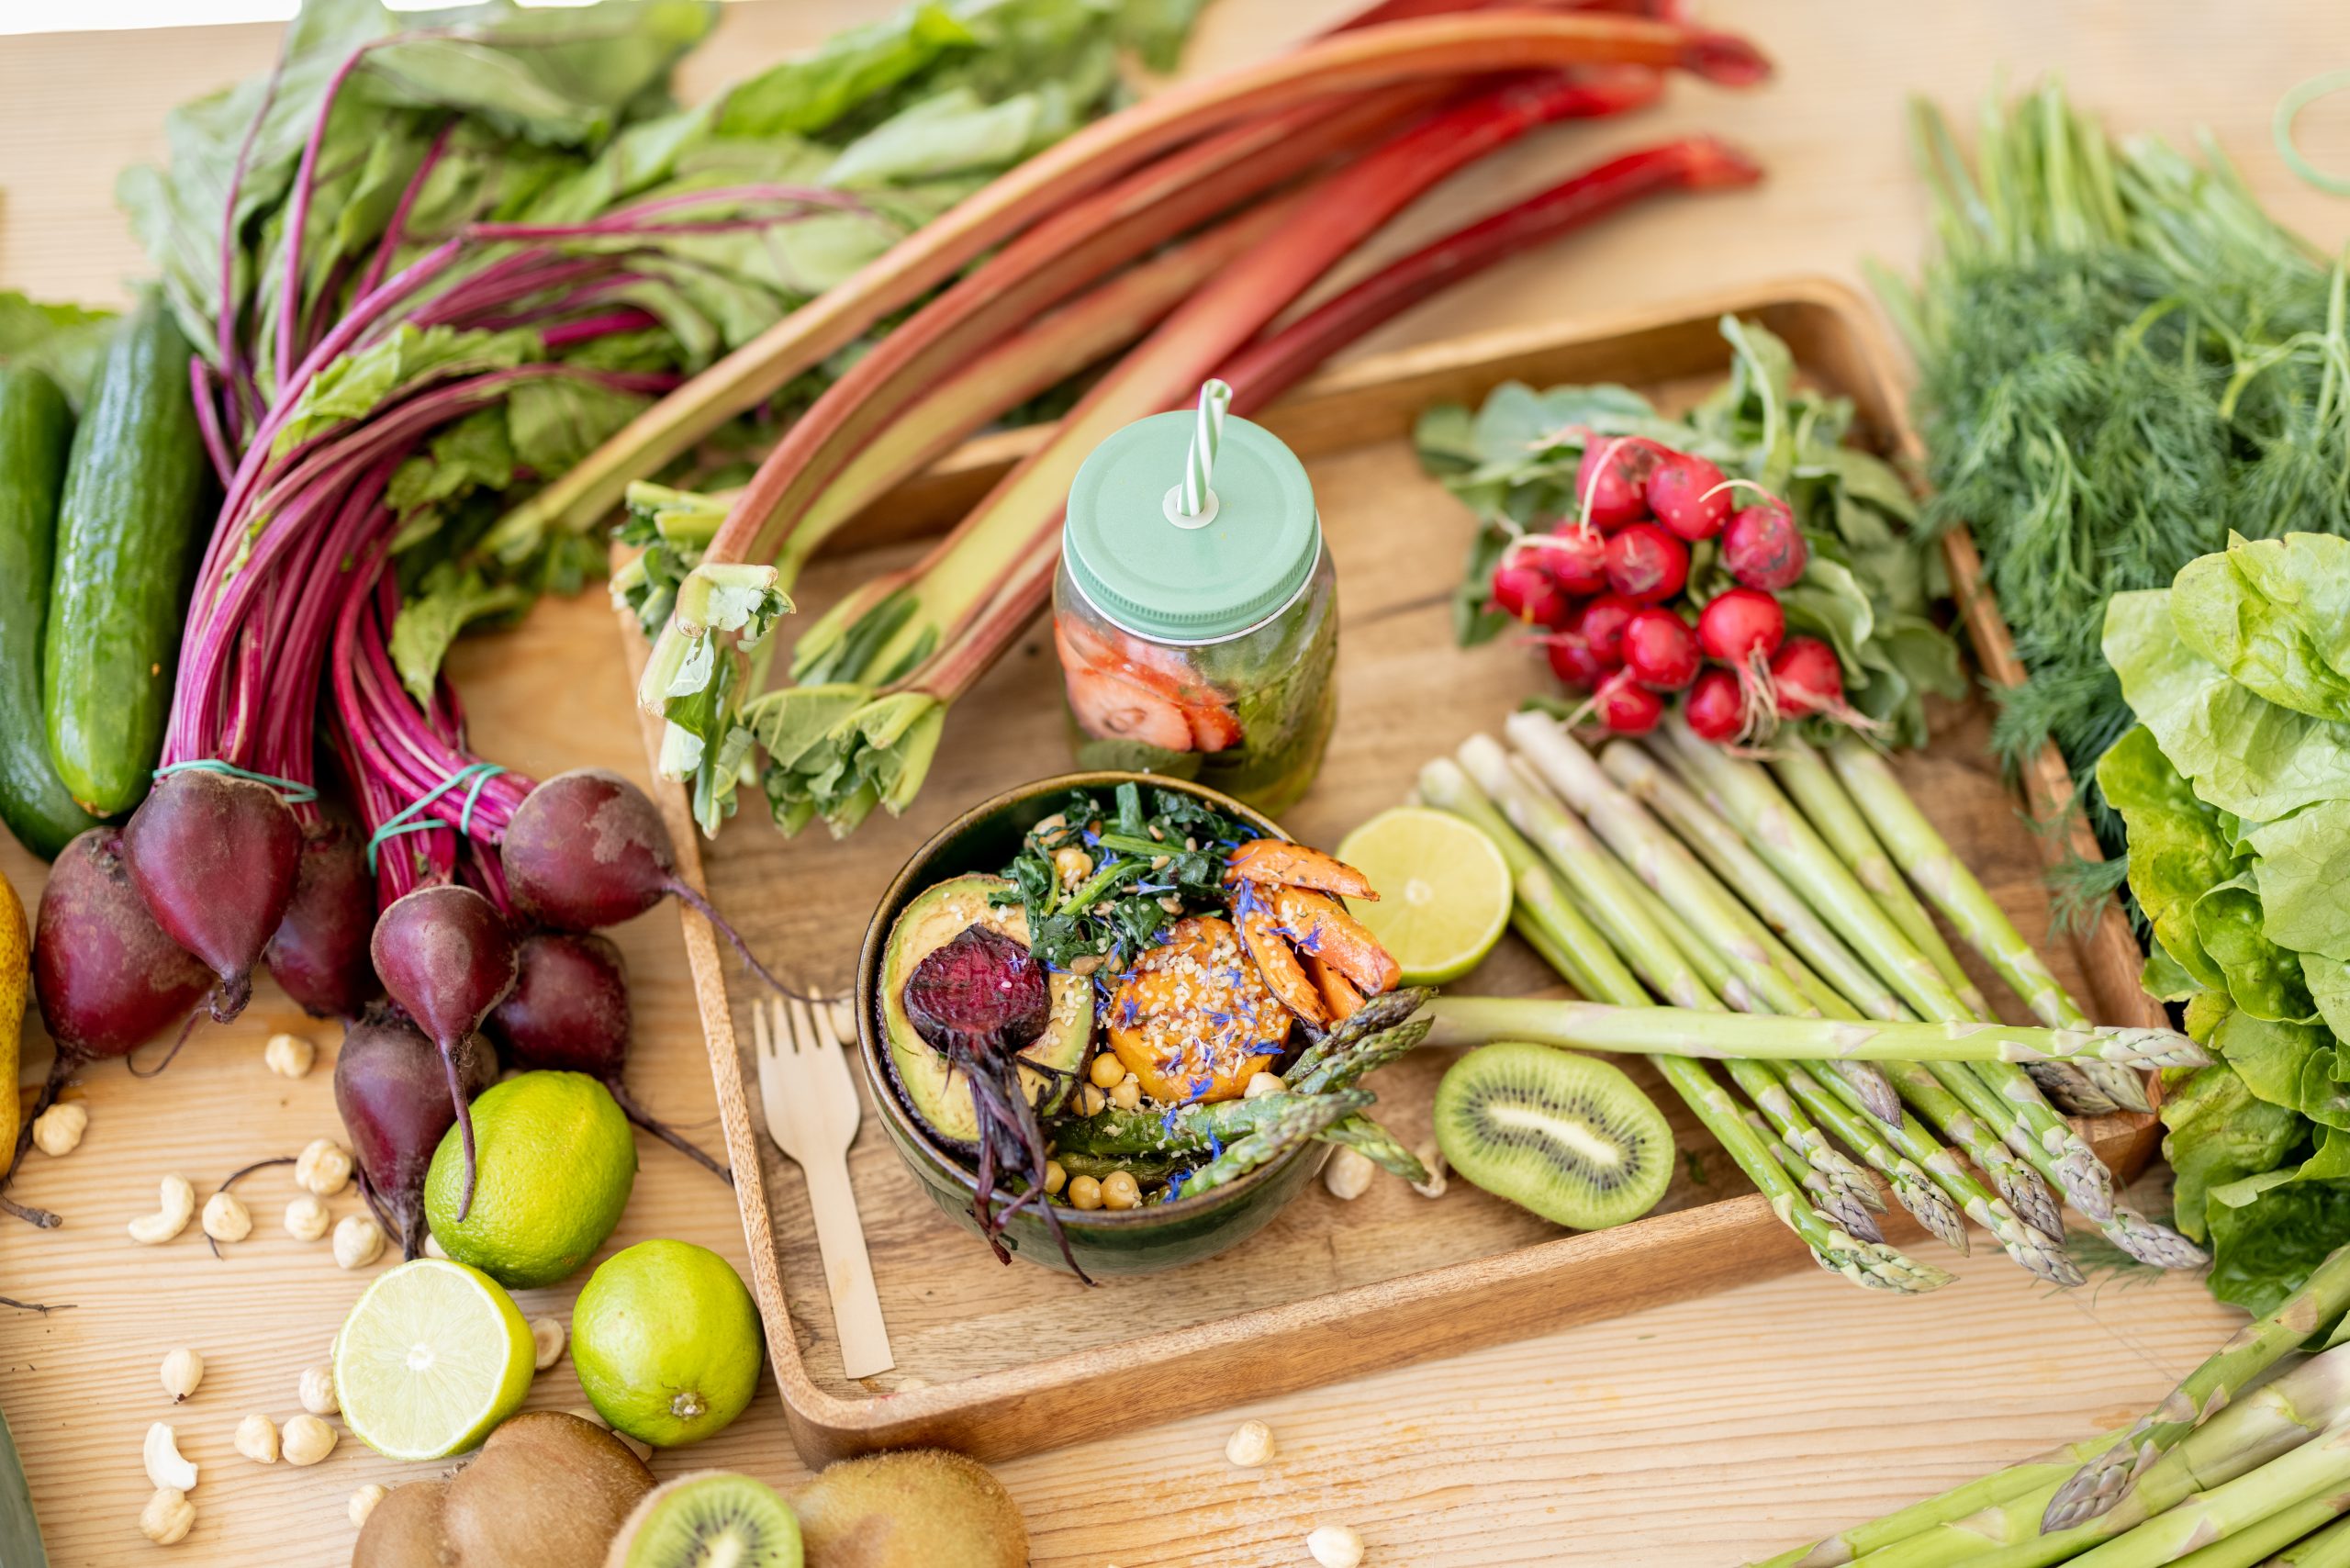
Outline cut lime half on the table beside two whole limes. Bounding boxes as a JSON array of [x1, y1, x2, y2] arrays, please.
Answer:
[[334, 1258, 533, 1460]]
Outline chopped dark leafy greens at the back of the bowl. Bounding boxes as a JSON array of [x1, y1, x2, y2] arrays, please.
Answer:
[[1003, 783, 1259, 969]]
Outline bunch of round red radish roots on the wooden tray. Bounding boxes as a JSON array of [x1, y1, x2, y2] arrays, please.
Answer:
[[1493, 432, 1866, 743]]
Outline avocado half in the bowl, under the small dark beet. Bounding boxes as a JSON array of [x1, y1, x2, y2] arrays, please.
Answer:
[[881, 875, 1092, 1154]]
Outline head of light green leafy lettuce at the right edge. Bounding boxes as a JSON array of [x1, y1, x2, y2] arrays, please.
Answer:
[[2097, 533, 2350, 1312]]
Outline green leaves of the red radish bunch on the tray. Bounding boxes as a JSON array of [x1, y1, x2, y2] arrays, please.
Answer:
[[1415, 318, 1964, 745]]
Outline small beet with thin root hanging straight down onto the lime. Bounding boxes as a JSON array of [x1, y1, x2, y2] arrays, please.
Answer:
[[369, 881, 515, 1220]]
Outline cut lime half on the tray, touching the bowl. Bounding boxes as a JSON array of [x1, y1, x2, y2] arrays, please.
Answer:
[[1337, 806, 1511, 985]]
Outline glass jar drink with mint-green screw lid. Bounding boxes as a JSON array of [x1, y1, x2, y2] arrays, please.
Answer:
[[1053, 414, 1337, 813]]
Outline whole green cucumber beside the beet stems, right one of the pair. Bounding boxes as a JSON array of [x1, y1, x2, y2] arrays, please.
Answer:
[[40, 294, 207, 816]]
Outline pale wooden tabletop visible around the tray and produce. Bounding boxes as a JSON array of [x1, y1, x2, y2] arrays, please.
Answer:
[[0, 0, 2350, 1568]]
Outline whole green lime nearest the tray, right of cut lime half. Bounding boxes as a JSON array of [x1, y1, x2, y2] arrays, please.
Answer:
[[571, 1241, 761, 1448]]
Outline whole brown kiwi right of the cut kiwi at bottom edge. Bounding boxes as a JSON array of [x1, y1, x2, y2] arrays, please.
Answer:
[[792, 1448, 1027, 1568]]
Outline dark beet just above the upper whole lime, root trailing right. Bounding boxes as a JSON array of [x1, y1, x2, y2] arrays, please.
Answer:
[[486, 931, 733, 1182]]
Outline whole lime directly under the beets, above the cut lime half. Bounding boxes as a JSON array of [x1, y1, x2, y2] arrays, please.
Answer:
[[425, 1072, 637, 1291]]
